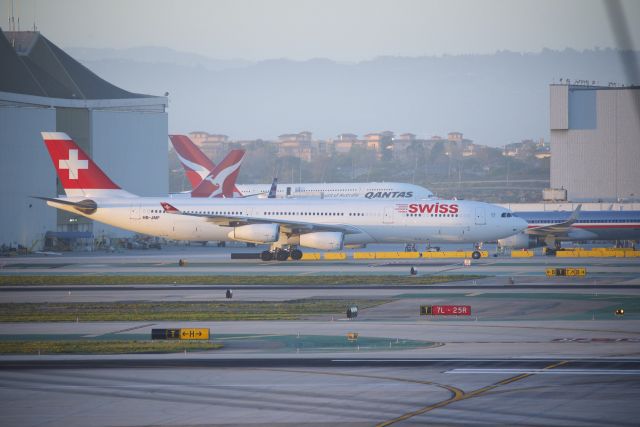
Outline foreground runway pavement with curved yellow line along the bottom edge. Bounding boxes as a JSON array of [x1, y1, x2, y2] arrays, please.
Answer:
[[0, 359, 640, 426]]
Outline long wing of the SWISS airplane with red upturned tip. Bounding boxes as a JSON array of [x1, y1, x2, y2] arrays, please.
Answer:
[[160, 202, 362, 234]]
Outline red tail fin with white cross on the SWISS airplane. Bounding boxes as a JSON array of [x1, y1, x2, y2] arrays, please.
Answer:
[[42, 132, 136, 197]]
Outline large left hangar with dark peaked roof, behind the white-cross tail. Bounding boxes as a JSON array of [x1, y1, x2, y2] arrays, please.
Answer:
[[0, 30, 168, 249]]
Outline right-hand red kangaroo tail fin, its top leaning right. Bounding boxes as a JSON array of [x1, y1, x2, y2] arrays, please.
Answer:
[[191, 150, 245, 197]]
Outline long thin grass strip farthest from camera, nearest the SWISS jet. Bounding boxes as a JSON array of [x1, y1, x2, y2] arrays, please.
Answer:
[[0, 276, 485, 286]]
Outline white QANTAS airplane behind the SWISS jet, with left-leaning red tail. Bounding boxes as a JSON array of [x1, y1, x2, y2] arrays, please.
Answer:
[[169, 135, 434, 200]]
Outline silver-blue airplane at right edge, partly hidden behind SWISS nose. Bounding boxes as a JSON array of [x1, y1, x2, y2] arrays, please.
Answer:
[[498, 205, 640, 249]]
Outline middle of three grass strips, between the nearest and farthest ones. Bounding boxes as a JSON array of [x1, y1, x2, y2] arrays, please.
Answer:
[[0, 299, 389, 322]]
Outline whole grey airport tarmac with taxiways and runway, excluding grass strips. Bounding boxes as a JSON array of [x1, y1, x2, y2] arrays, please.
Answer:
[[0, 248, 640, 427]]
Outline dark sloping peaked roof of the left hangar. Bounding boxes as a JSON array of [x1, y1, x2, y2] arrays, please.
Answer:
[[0, 29, 151, 100]]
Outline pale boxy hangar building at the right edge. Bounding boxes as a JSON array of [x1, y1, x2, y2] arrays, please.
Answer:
[[550, 84, 640, 202]]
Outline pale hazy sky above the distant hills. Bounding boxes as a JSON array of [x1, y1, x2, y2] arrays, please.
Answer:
[[0, 0, 640, 61]]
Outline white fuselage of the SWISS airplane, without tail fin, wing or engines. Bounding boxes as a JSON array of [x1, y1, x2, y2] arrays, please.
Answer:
[[47, 197, 526, 245]]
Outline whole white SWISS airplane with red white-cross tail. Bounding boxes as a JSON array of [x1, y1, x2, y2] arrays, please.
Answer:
[[38, 132, 527, 261]]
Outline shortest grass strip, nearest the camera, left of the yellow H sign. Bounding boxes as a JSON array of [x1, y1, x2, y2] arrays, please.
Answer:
[[0, 340, 222, 355]]
